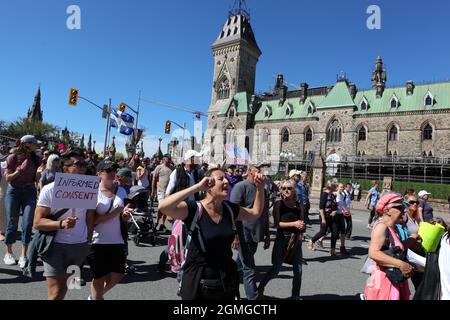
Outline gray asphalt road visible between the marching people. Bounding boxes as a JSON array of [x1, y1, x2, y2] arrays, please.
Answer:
[[0, 206, 380, 300]]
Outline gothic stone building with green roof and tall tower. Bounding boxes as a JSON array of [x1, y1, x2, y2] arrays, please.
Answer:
[[203, 11, 450, 168]]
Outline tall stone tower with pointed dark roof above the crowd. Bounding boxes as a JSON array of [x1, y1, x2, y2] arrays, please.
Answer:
[[204, 0, 261, 163]]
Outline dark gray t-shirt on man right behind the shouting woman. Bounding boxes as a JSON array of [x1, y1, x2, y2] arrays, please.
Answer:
[[230, 180, 267, 242]]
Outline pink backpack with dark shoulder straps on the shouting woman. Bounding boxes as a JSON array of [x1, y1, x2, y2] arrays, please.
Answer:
[[167, 202, 235, 273]]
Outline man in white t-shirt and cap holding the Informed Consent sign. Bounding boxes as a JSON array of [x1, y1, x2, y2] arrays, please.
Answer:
[[34, 150, 95, 300]]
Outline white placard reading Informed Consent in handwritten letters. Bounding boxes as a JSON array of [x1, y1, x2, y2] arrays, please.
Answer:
[[52, 173, 100, 209]]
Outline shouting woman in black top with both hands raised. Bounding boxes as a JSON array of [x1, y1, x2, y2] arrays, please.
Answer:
[[159, 168, 264, 300]]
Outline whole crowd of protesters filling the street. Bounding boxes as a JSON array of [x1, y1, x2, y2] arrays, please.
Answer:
[[0, 135, 450, 300]]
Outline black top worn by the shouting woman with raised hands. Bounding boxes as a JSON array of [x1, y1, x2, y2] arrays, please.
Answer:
[[184, 200, 240, 270]]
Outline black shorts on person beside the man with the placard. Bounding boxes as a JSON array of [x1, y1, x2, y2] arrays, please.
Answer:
[[88, 244, 126, 279]]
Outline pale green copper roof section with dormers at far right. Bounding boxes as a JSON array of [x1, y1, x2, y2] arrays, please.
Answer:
[[355, 82, 450, 114]]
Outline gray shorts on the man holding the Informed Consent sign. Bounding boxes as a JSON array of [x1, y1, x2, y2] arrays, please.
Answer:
[[42, 242, 91, 277]]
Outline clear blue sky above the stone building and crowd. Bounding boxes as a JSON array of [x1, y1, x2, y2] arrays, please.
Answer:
[[0, 0, 450, 154]]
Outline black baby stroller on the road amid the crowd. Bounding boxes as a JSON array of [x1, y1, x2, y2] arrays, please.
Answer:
[[128, 186, 156, 246]]
